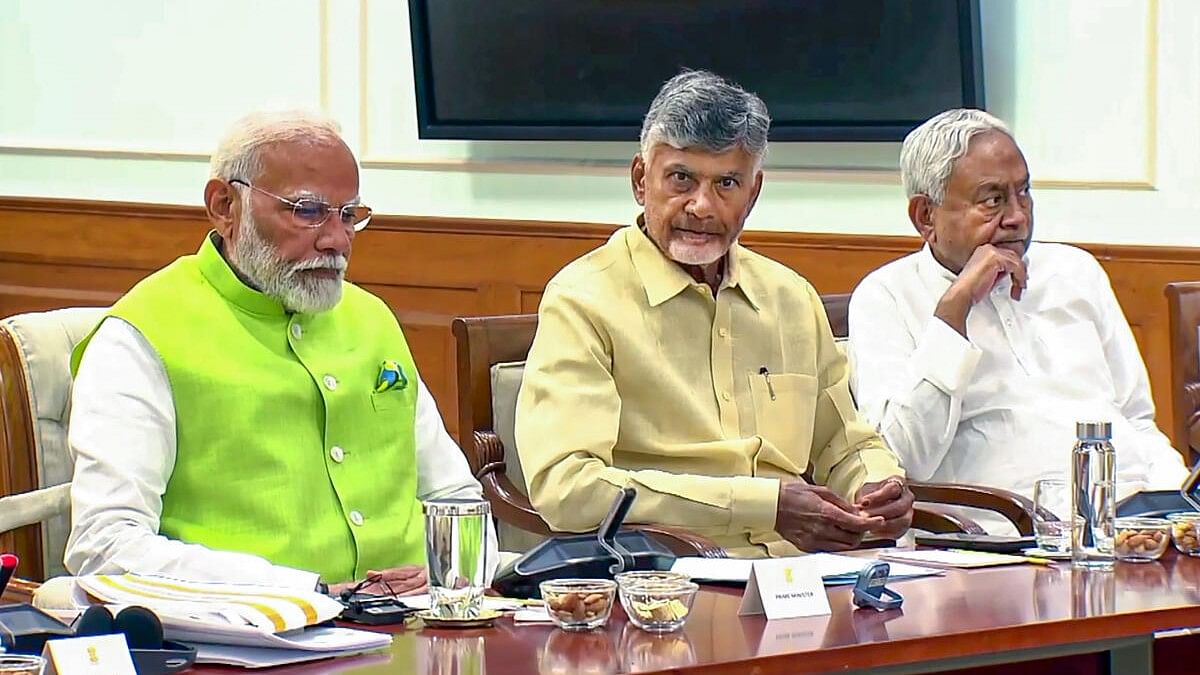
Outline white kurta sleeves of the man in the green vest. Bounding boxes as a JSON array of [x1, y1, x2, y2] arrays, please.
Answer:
[[64, 317, 498, 589]]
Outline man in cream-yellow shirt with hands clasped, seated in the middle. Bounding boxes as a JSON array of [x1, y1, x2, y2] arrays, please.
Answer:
[[516, 72, 912, 556]]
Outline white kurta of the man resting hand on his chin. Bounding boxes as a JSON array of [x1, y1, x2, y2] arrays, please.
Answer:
[[850, 243, 1187, 532]]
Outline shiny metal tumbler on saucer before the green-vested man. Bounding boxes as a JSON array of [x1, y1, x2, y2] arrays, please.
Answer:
[[421, 500, 492, 619]]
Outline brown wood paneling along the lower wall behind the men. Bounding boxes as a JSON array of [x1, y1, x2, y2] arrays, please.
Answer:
[[0, 197, 1200, 449]]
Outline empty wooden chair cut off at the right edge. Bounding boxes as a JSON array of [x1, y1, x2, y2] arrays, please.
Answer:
[[1166, 281, 1200, 466]]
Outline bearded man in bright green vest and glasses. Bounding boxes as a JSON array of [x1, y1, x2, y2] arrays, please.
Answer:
[[65, 113, 496, 592]]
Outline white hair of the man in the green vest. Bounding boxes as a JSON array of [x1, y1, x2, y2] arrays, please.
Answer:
[[209, 110, 342, 183]]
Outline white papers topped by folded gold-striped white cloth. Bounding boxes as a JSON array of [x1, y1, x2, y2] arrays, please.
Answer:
[[76, 574, 391, 665]]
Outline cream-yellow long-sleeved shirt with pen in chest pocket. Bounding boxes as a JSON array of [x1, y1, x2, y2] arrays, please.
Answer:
[[516, 227, 902, 556]]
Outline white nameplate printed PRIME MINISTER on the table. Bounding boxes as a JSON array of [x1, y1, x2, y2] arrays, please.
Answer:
[[738, 556, 832, 620]]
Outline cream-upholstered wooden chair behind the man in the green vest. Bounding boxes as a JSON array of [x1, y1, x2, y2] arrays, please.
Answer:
[[0, 307, 106, 580]]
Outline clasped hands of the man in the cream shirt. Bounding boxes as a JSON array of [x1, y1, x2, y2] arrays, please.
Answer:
[[775, 477, 913, 551]]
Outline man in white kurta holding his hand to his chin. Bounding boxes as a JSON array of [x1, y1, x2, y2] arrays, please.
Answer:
[[850, 109, 1187, 533]]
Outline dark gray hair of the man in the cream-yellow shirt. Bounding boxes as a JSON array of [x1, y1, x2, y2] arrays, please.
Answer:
[[642, 71, 770, 167]]
